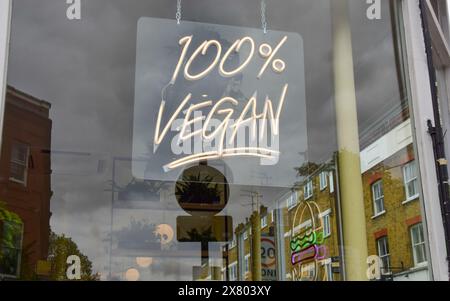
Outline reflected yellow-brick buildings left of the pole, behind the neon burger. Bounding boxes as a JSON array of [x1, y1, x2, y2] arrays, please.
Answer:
[[222, 158, 341, 281]]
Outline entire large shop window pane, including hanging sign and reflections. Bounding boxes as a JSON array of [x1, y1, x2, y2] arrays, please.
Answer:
[[0, 0, 436, 281]]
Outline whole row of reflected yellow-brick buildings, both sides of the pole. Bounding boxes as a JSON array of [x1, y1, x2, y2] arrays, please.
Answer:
[[218, 119, 428, 280]]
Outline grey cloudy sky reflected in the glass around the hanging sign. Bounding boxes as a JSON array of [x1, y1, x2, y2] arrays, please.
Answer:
[[8, 0, 398, 279]]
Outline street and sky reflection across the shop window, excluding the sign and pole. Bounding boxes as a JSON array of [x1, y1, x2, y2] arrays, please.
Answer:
[[0, 0, 428, 281]]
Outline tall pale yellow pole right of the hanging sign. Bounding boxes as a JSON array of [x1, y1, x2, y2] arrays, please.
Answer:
[[330, 0, 368, 281]]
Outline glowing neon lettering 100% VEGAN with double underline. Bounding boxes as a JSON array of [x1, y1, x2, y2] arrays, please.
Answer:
[[154, 35, 289, 170]]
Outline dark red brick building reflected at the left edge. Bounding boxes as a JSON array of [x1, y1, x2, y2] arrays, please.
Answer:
[[0, 87, 52, 271]]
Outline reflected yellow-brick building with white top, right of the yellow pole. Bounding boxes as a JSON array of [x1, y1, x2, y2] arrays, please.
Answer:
[[361, 119, 428, 280]]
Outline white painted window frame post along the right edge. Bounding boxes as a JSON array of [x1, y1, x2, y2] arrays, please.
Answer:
[[402, 0, 448, 281]]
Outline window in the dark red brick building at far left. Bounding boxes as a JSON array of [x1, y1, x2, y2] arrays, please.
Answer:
[[10, 142, 30, 184]]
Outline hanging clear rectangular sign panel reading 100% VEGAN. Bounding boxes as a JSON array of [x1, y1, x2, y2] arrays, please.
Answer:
[[133, 18, 307, 187]]
